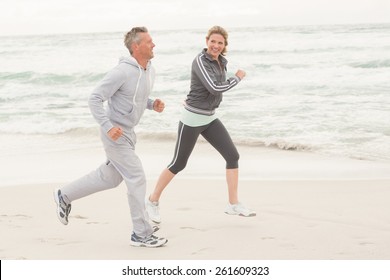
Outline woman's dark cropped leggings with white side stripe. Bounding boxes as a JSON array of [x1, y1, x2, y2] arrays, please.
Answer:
[[168, 119, 240, 174]]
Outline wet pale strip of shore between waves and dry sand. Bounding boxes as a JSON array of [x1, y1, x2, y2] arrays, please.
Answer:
[[0, 134, 390, 188]]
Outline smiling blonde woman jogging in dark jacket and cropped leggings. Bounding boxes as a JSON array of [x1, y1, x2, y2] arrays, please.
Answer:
[[146, 26, 256, 223]]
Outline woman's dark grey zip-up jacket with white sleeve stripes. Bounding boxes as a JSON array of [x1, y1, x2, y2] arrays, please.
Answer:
[[184, 49, 240, 116]]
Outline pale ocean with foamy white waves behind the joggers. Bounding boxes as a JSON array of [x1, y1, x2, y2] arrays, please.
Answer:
[[0, 24, 390, 162]]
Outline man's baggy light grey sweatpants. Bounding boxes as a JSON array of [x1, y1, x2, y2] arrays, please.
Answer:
[[61, 133, 153, 237]]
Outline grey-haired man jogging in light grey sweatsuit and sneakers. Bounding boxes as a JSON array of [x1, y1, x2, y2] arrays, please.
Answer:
[[54, 27, 168, 247]]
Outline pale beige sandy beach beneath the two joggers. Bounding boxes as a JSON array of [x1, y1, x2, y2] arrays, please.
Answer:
[[0, 136, 390, 260]]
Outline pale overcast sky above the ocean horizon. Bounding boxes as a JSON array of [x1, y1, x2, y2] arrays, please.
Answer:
[[0, 0, 390, 35]]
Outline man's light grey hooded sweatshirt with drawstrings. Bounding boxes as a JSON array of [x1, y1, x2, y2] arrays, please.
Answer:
[[88, 56, 155, 145]]
